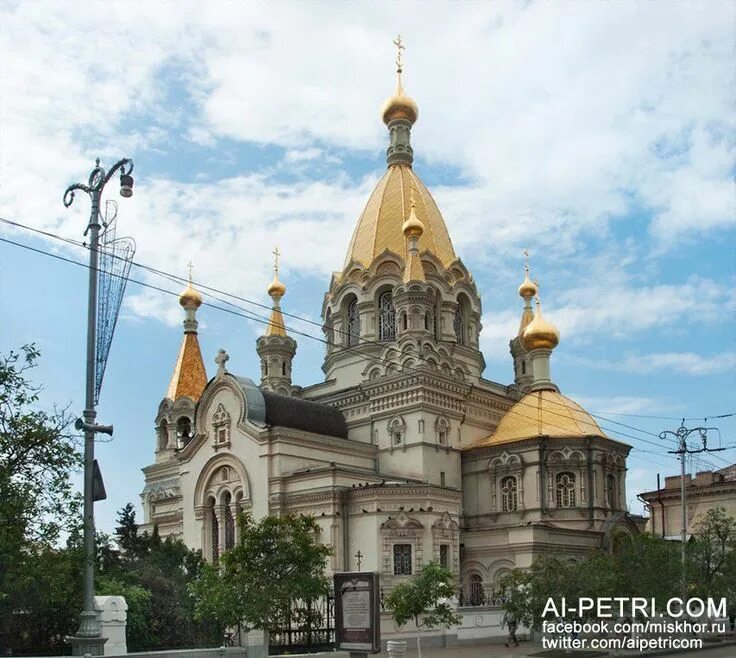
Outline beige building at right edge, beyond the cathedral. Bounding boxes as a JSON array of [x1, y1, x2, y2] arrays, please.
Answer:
[[639, 465, 736, 539]]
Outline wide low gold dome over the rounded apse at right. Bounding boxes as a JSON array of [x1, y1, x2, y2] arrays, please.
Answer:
[[470, 390, 608, 448]]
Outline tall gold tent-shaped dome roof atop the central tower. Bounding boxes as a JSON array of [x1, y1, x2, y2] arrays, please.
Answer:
[[345, 164, 457, 267]]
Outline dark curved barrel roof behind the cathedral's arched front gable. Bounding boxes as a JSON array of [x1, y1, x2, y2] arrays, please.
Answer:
[[233, 375, 348, 439]]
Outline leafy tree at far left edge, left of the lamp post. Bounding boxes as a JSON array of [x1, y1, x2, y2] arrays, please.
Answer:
[[0, 345, 81, 650]]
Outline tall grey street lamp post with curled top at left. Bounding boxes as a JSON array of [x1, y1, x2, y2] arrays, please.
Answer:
[[64, 158, 133, 656]]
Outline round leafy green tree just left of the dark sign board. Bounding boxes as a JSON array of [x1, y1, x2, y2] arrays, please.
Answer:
[[190, 514, 331, 637]]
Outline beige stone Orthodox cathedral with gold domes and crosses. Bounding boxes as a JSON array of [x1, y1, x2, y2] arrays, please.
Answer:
[[141, 52, 637, 605]]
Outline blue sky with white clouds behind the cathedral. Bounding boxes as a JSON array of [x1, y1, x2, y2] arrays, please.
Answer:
[[0, 1, 736, 531]]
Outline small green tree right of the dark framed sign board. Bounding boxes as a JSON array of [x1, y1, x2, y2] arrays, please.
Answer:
[[386, 562, 461, 658]]
